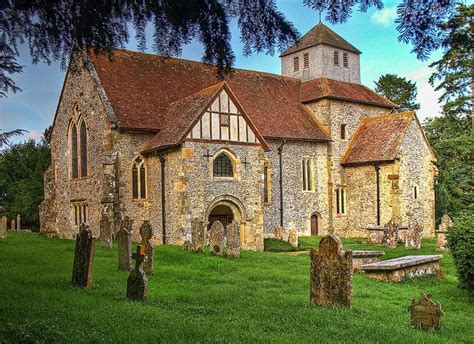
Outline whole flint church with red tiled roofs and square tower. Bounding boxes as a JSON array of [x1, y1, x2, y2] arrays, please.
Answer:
[[40, 23, 437, 251]]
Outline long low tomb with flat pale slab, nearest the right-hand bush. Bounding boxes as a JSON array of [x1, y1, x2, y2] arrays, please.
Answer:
[[362, 255, 443, 282]]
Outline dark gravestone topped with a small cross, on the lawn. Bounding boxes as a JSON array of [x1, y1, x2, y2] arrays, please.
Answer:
[[127, 245, 148, 301]]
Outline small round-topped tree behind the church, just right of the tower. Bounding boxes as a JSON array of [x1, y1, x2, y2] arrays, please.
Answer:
[[375, 74, 420, 110]]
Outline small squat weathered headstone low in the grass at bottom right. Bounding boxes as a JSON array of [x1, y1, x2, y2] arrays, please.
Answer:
[[408, 293, 444, 331]]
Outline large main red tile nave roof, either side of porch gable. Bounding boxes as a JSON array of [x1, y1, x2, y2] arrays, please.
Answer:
[[90, 50, 328, 141]]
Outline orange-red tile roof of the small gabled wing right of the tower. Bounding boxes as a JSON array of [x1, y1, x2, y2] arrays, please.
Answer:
[[341, 112, 415, 165]]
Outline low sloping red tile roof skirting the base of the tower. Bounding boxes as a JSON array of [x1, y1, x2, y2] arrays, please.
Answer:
[[300, 78, 399, 109]]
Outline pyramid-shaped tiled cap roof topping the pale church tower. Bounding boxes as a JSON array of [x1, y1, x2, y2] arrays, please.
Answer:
[[280, 23, 361, 57]]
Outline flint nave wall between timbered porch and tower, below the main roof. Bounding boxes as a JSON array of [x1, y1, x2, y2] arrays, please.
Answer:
[[264, 140, 328, 236]]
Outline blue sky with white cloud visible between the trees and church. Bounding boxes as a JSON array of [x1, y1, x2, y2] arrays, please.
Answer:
[[0, 0, 462, 141]]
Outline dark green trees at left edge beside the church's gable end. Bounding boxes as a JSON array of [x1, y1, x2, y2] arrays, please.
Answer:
[[0, 136, 50, 229]]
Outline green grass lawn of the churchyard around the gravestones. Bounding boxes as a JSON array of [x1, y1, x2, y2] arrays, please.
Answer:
[[0, 233, 474, 343]]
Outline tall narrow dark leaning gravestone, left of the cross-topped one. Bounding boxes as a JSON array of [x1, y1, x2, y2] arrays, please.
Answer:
[[72, 223, 94, 288]]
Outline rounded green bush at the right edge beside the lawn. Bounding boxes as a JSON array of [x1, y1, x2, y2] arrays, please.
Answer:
[[448, 213, 474, 292]]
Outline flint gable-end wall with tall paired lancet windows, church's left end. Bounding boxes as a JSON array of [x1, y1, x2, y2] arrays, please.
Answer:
[[40, 58, 112, 238]]
